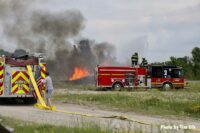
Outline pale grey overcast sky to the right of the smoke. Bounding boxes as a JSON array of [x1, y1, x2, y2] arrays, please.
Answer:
[[1, 0, 200, 62]]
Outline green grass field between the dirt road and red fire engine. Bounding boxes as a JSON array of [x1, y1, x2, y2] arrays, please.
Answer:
[[53, 82, 200, 118]]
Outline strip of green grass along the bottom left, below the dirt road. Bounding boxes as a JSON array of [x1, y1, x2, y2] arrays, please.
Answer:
[[0, 117, 112, 133]]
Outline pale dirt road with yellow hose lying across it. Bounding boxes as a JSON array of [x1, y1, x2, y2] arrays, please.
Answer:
[[0, 97, 200, 132]]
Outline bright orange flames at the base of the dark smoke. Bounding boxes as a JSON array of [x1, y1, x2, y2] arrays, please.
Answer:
[[69, 67, 90, 80]]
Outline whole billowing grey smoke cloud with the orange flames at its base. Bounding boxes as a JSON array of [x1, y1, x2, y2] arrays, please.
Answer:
[[0, 0, 116, 80]]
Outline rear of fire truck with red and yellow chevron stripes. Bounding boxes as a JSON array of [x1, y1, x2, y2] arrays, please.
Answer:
[[0, 54, 46, 102]]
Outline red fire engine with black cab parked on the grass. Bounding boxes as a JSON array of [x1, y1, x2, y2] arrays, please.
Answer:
[[96, 65, 187, 90]]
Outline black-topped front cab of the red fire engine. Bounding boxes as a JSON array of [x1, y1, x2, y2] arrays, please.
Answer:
[[148, 65, 188, 89]]
